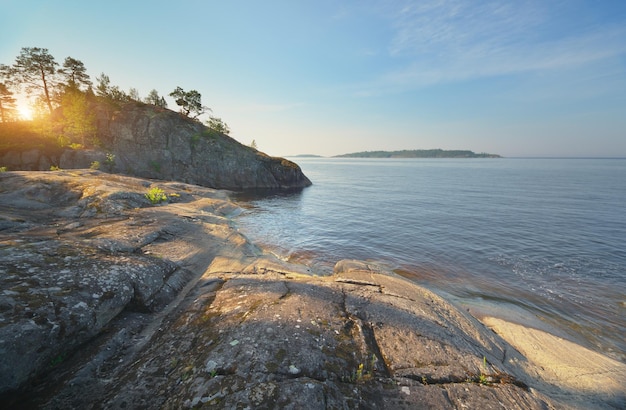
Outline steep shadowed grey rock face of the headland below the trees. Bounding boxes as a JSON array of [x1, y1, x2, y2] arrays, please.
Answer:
[[0, 103, 311, 190]]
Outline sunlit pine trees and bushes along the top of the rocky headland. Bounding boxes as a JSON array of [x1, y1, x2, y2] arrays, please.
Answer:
[[0, 47, 229, 151]]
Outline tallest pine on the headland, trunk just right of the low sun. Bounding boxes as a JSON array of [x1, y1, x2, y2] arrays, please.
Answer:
[[8, 47, 58, 114]]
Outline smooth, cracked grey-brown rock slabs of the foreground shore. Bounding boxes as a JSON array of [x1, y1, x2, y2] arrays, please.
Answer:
[[0, 170, 626, 409]]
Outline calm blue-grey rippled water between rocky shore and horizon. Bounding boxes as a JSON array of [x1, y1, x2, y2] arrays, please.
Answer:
[[238, 158, 626, 361]]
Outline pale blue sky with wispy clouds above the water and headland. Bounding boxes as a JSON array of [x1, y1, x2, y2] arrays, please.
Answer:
[[0, 0, 626, 157]]
